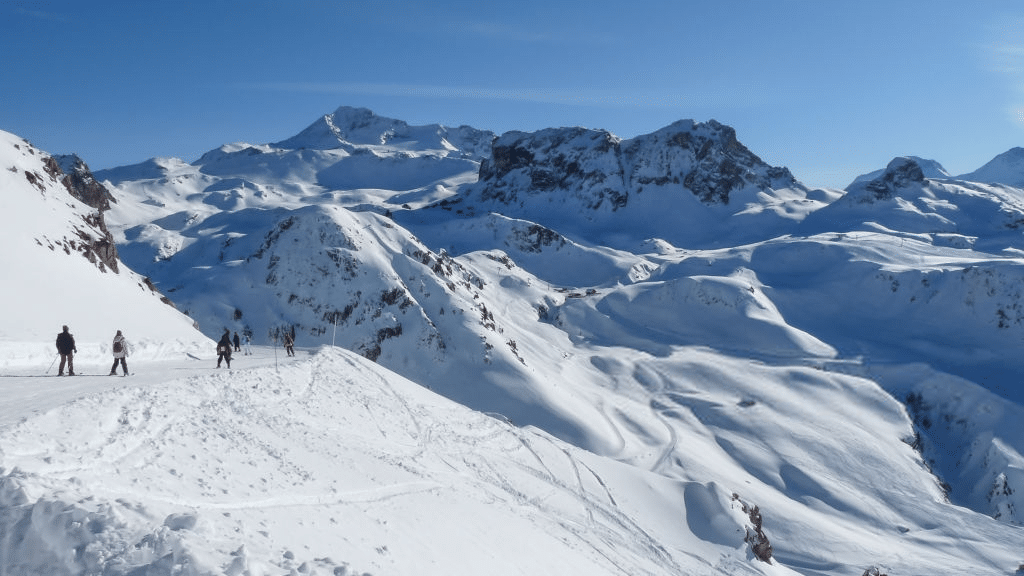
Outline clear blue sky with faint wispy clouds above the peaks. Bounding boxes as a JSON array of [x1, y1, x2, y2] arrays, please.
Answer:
[[0, 0, 1024, 188]]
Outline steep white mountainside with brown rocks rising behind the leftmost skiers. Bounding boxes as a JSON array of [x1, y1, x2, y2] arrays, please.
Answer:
[[0, 132, 209, 365]]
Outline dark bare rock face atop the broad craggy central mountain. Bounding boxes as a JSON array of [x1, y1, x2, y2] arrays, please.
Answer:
[[478, 120, 796, 211]]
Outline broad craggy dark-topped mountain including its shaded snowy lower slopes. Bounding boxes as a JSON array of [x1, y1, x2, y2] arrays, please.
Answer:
[[419, 120, 823, 246]]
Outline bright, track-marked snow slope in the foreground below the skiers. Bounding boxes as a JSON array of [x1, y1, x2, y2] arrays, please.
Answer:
[[0, 348, 765, 576]]
